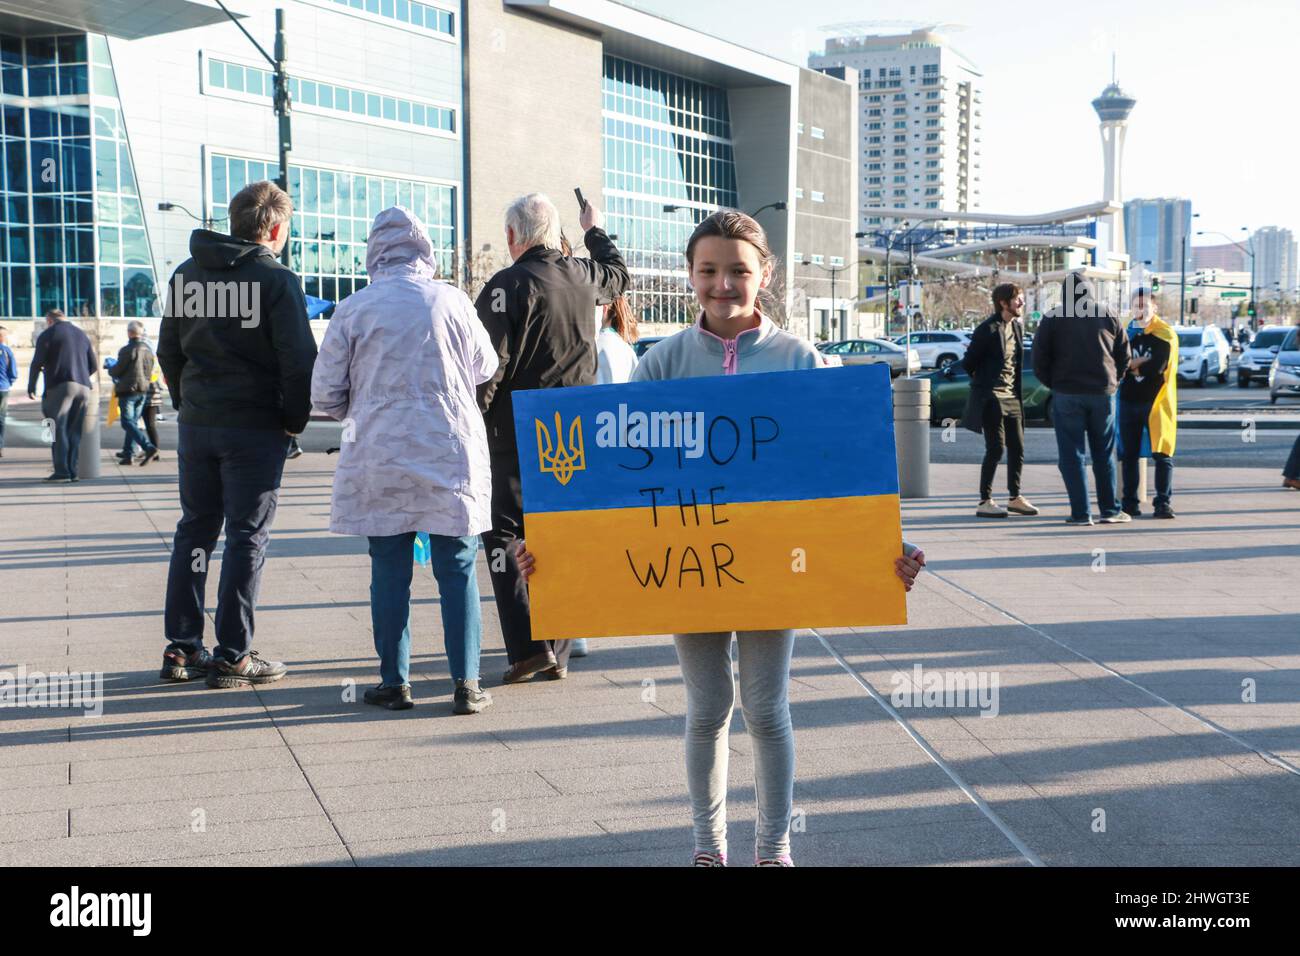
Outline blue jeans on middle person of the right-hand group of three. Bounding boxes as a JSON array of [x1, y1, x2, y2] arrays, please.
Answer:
[[1052, 392, 1119, 519]]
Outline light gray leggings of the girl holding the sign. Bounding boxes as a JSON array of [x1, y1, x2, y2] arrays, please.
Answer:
[[673, 631, 794, 858]]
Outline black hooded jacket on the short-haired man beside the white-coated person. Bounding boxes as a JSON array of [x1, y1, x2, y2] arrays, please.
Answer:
[[157, 229, 316, 433]]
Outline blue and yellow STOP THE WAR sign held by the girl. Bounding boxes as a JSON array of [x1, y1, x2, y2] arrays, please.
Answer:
[[512, 365, 906, 640]]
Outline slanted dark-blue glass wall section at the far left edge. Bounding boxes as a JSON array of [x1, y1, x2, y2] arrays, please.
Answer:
[[0, 34, 159, 317]]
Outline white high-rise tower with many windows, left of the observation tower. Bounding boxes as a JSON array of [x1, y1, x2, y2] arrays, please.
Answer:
[[809, 26, 982, 233]]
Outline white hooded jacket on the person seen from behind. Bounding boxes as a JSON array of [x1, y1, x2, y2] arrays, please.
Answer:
[[312, 206, 497, 537]]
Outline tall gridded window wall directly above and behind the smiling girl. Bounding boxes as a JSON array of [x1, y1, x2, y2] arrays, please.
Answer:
[[603, 56, 737, 323]]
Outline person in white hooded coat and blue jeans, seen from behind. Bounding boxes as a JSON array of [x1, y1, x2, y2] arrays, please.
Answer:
[[312, 207, 498, 714]]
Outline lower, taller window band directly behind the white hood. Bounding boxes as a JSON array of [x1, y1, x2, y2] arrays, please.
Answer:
[[208, 153, 456, 302]]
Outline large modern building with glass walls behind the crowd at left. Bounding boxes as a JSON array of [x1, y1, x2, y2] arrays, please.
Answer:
[[0, 0, 855, 348]]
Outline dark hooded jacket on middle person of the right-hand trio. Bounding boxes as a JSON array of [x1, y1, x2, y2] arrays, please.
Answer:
[[1034, 273, 1130, 395]]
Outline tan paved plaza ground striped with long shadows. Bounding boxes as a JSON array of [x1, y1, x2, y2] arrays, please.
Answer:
[[0, 449, 1300, 866]]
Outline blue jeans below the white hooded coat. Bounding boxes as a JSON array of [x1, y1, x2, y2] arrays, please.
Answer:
[[369, 531, 482, 687]]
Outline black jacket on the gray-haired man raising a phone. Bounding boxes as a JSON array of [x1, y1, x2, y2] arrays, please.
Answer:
[[475, 229, 629, 455]]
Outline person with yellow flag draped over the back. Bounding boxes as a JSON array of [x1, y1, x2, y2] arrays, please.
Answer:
[[1119, 287, 1178, 519]]
